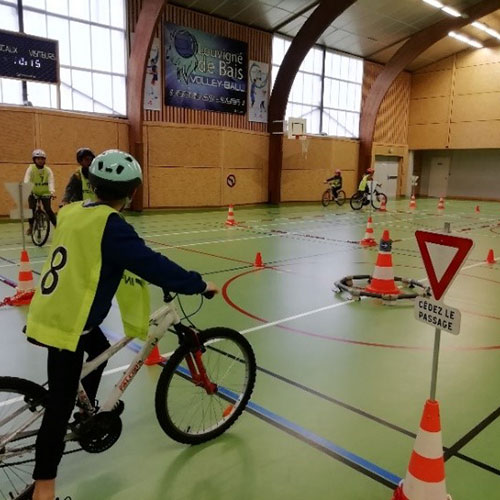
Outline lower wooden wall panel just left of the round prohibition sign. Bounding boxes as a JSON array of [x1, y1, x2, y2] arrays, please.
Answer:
[[149, 167, 221, 208]]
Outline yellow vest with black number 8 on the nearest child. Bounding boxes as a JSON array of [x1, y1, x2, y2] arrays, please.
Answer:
[[26, 202, 150, 351]]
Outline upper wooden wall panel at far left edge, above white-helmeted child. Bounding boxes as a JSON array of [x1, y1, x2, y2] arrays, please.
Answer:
[[0, 109, 38, 162]]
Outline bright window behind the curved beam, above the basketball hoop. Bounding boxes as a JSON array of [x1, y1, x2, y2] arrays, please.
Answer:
[[272, 36, 363, 138]]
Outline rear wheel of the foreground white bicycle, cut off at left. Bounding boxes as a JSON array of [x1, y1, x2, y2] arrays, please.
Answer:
[[0, 377, 48, 500]]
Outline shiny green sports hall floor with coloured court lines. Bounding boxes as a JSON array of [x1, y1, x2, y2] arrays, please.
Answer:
[[0, 199, 500, 500]]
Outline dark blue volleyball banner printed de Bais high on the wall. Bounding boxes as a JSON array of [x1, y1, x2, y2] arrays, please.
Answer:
[[165, 23, 248, 115]]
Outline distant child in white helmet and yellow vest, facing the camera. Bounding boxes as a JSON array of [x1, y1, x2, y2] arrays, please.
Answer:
[[24, 149, 57, 235]]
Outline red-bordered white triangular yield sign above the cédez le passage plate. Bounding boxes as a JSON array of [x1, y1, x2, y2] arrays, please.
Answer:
[[415, 231, 474, 300]]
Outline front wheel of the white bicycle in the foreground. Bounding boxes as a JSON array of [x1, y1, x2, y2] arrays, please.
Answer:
[[155, 327, 257, 444]]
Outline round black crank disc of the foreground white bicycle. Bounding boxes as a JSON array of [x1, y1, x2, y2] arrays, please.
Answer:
[[77, 412, 123, 453]]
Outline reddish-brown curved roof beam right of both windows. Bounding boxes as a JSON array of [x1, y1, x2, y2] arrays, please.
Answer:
[[358, 0, 500, 175]]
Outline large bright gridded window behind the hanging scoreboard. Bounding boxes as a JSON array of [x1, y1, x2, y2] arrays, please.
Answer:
[[0, 0, 127, 115]]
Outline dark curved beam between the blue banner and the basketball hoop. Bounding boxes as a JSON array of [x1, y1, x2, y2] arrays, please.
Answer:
[[268, 0, 358, 203]]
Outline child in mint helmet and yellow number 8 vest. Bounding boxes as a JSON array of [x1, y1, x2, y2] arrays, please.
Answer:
[[26, 150, 218, 500]]
